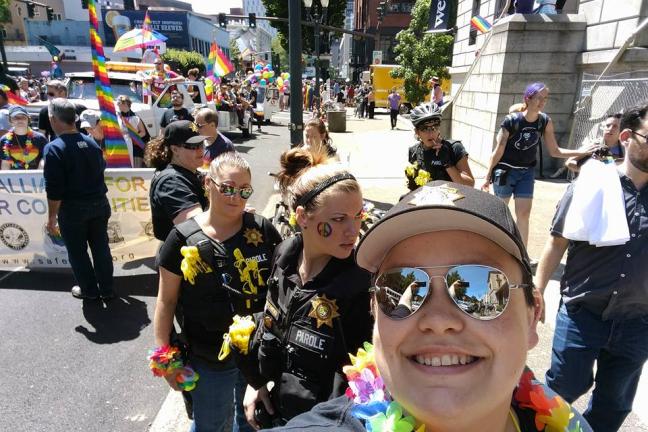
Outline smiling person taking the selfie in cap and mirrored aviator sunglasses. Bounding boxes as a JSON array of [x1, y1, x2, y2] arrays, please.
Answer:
[[264, 181, 591, 432]]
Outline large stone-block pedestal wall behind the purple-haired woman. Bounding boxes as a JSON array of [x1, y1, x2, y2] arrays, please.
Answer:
[[451, 14, 586, 166]]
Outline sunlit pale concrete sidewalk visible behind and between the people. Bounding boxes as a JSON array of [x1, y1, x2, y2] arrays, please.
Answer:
[[150, 108, 648, 432]]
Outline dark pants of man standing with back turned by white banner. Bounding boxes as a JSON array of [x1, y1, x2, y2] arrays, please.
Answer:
[[58, 198, 113, 296]]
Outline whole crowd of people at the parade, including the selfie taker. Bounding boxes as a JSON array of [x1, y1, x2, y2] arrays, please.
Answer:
[[0, 69, 648, 432]]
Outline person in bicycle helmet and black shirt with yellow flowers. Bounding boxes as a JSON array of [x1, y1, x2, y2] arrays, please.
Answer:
[[405, 103, 475, 190]]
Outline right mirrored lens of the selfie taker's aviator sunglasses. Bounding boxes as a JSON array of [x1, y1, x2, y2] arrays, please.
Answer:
[[446, 265, 509, 320]]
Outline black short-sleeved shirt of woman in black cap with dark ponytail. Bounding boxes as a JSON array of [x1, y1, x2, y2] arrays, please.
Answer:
[[149, 164, 209, 241]]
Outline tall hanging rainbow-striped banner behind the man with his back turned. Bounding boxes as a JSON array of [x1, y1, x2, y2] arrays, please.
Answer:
[[88, 0, 131, 168]]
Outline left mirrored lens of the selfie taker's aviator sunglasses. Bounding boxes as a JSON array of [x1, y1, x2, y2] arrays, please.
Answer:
[[376, 268, 429, 319]]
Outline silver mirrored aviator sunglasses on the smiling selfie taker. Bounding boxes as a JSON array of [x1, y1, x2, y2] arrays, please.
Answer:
[[372, 264, 530, 321]]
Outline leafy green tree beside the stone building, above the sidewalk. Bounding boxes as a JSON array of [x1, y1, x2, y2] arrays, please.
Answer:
[[391, 0, 453, 105]]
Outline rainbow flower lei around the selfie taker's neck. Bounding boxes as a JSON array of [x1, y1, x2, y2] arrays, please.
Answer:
[[342, 342, 584, 432]]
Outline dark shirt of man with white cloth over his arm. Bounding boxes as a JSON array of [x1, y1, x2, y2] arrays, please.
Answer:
[[551, 174, 648, 320]]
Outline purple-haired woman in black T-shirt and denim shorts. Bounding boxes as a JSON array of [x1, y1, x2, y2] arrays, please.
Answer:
[[482, 82, 594, 250]]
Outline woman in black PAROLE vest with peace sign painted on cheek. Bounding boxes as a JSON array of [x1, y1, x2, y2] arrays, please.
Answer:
[[242, 148, 372, 427]]
